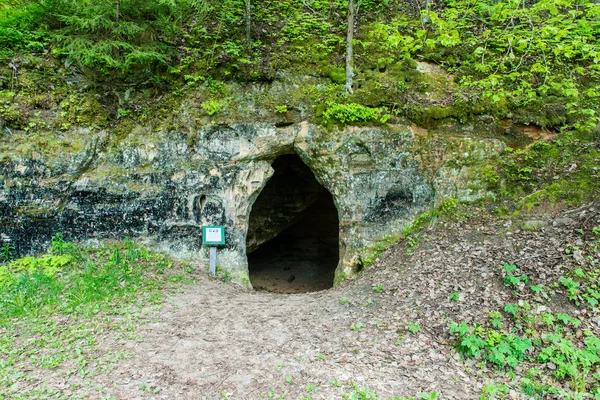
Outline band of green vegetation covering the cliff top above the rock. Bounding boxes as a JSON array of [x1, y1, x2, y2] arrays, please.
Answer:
[[0, 0, 600, 132]]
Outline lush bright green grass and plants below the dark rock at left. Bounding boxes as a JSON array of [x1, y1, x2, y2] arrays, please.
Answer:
[[0, 235, 186, 325]]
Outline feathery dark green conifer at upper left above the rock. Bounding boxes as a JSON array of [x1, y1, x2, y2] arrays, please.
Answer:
[[44, 0, 191, 80]]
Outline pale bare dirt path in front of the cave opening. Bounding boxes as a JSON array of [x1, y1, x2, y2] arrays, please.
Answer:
[[102, 280, 469, 399]]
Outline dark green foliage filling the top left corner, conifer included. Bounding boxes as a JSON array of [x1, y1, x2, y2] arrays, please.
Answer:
[[0, 0, 205, 81]]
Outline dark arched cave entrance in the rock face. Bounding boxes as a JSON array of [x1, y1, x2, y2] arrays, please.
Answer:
[[246, 154, 339, 293]]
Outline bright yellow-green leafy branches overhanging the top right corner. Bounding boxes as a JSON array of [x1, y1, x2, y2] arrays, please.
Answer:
[[415, 0, 600, 131]]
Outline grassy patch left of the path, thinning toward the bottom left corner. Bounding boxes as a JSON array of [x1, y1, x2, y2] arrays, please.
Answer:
[[0, 235, 191, 399]]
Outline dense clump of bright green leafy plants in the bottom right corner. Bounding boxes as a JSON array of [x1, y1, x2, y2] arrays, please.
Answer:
[[450, 302, 600, 398]]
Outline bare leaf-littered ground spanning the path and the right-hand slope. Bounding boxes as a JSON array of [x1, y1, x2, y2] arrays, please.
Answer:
[[0, 204, 600, 399]]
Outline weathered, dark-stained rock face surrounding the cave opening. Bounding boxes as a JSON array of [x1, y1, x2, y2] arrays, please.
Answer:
[[0, 123, 503, 286]]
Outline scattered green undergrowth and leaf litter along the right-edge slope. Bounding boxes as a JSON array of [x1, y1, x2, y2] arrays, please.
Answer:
[[449, 222, 600, 399]]
